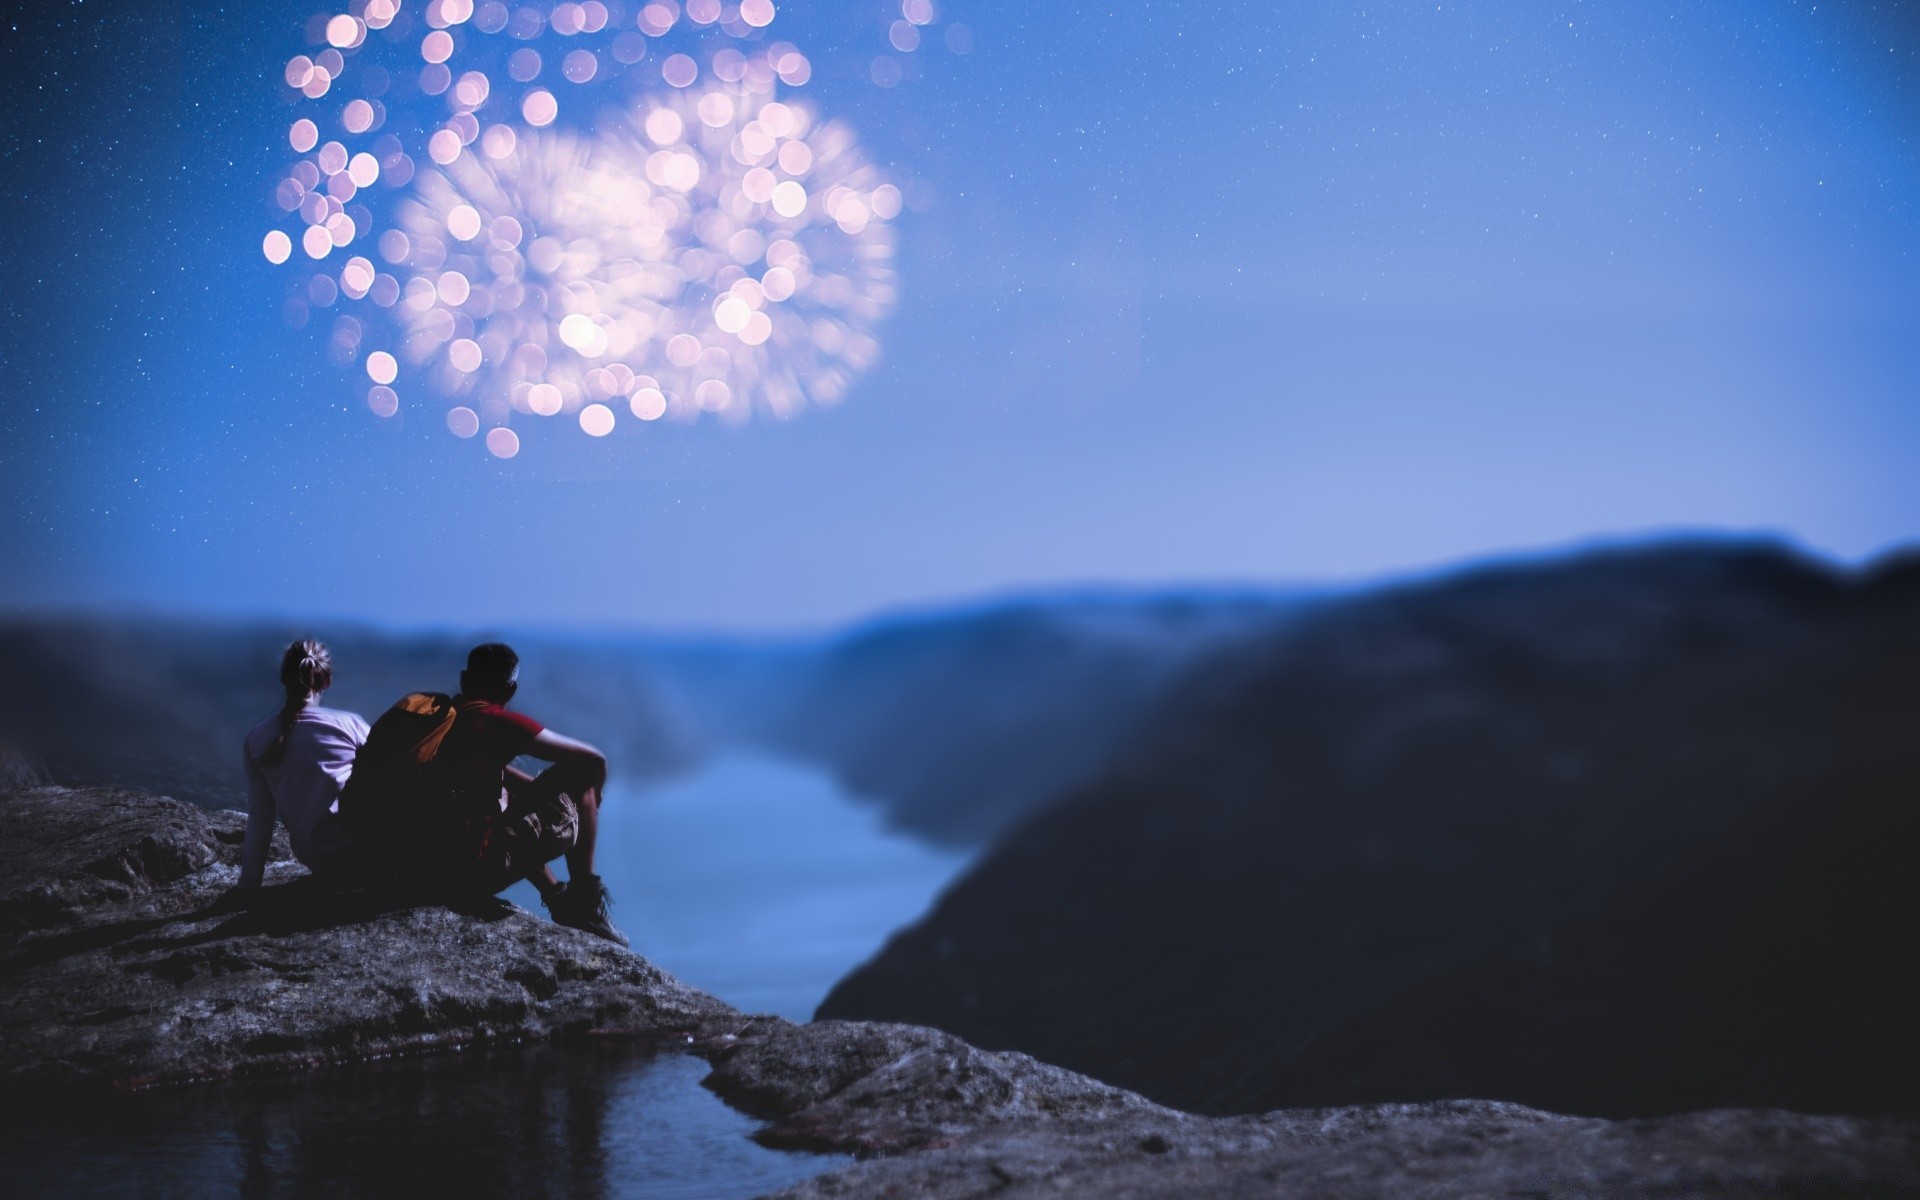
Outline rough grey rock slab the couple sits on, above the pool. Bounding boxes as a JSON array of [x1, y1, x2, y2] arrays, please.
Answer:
[[0, 787, 745, 1087]]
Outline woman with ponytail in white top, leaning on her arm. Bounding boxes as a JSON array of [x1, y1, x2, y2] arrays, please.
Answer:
[[236, 637, 367, 895]]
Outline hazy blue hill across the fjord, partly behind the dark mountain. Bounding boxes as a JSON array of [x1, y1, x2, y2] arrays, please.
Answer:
[[668, 591, 1311, 845]]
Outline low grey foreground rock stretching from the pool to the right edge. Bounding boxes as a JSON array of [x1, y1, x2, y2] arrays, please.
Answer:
[[708, 1021, 1920, 1200]]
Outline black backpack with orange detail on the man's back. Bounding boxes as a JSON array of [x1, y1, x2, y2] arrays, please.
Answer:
[[340, 691, 459, 864]]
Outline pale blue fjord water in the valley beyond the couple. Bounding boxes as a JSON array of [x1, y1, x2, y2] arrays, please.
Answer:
[[507, 755, 966, 1021]]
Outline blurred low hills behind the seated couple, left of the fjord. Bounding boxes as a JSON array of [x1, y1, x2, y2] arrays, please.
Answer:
[[0, 616, 691, 808]]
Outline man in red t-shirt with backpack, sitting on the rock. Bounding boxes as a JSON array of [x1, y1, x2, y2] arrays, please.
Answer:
[[342, 641, 626, 947]]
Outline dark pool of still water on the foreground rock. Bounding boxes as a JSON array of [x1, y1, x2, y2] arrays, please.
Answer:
[[0, 1043, 843, 1200]]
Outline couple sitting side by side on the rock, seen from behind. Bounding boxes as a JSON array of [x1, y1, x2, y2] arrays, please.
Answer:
[[234, 639, 626, 945]]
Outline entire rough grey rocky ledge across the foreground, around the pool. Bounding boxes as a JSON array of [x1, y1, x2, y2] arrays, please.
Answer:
[[0, 787, 1920, 1200]]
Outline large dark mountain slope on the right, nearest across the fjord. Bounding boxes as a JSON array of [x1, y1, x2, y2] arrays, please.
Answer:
[[820, 543, 1920, 1116]]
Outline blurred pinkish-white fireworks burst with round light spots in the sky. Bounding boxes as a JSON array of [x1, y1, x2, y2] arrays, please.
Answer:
[[263, 0, 900, 457]]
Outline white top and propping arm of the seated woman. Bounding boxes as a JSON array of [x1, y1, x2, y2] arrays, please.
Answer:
[[240, 705, 367, 887]]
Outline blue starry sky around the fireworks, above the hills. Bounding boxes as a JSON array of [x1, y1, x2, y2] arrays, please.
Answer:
[[0, 0, 1920, 630]]
